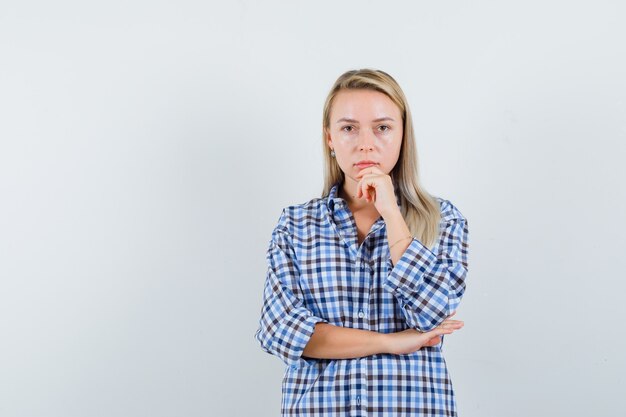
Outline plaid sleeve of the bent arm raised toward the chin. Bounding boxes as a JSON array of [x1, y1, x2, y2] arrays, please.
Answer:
[[383, 217, 468, 332]]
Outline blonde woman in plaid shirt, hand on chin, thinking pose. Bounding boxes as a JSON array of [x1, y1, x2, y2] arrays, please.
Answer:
[[255, 69, 468, 416]]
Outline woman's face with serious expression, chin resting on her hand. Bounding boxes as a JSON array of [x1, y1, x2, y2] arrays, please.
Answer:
[[326, 90, 403, 182]]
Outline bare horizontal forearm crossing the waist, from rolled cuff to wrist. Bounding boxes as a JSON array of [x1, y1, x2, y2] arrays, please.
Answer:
[[303, 323, 386, 359]]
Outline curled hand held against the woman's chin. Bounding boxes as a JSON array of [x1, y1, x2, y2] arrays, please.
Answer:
[[356, 166, 399, 217]]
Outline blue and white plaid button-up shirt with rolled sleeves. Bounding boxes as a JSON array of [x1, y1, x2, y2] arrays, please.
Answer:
[[254, 183, 468, 417]]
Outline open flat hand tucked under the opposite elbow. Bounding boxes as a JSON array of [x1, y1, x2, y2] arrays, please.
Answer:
[[385, 312, 464, 355]]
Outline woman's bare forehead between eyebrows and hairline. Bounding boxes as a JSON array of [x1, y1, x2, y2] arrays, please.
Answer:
[[330, 90, 400, 122]]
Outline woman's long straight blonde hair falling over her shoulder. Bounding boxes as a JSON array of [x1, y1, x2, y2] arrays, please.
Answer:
[[322, 69, 441, 249]]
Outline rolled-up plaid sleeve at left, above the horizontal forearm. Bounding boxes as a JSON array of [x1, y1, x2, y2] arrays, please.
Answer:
[[254, 211, 328, 367]]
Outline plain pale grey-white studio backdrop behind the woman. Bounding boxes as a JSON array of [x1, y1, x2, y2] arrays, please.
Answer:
[[0, 0, 626, 417]]
